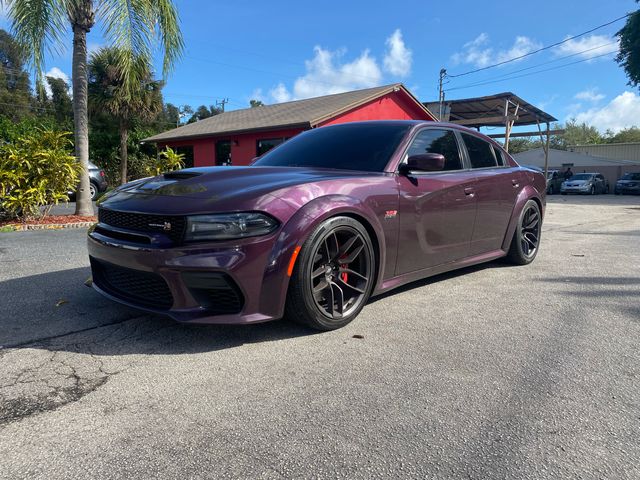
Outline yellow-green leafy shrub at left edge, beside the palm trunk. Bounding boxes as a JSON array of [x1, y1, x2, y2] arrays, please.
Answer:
[[0, 128, 82, 218]]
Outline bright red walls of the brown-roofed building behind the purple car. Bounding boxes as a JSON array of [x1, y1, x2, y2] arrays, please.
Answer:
[[158, 90, 435, 167]]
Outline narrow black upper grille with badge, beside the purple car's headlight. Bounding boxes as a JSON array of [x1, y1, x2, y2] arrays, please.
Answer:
[[98, 208, 186, 244]]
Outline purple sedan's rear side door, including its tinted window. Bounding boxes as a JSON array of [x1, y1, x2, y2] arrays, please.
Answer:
[[460, 133, 522, 255]]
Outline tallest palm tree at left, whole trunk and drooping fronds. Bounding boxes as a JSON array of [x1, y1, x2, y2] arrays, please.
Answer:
[[5, 0, 183, 216]]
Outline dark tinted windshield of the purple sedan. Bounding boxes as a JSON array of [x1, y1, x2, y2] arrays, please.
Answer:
[[254, 122, 413, 172]]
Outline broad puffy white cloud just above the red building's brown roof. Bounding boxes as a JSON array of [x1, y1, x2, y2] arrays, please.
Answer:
[[270, 46, 382, 102]]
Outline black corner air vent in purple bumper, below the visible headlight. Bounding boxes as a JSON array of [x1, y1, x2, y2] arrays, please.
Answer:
[[182, 272, 244, 315]]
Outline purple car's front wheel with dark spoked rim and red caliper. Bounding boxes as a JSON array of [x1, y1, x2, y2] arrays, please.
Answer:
[[285, 217, 376, 331]]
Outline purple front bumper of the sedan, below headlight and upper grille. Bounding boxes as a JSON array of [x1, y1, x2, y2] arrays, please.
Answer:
[[88, 229, 286, 324]]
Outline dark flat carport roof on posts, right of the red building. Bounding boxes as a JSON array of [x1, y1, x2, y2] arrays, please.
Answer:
[[426, 92, 558, 127]]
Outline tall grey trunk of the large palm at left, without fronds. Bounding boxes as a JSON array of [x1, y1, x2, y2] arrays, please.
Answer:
[[69, 0, 94, 217]]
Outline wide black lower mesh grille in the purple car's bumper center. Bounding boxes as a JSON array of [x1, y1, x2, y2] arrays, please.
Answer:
[[90, 257, 173, 310]]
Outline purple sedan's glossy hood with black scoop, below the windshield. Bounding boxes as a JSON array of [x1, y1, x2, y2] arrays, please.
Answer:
[[99, 167, 381, 213]]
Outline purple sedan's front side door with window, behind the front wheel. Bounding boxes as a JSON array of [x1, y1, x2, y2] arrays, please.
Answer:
[[396, 128, 476, 275]]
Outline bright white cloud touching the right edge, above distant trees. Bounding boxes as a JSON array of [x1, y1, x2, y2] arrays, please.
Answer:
[[572, 92, 640, 132]]
